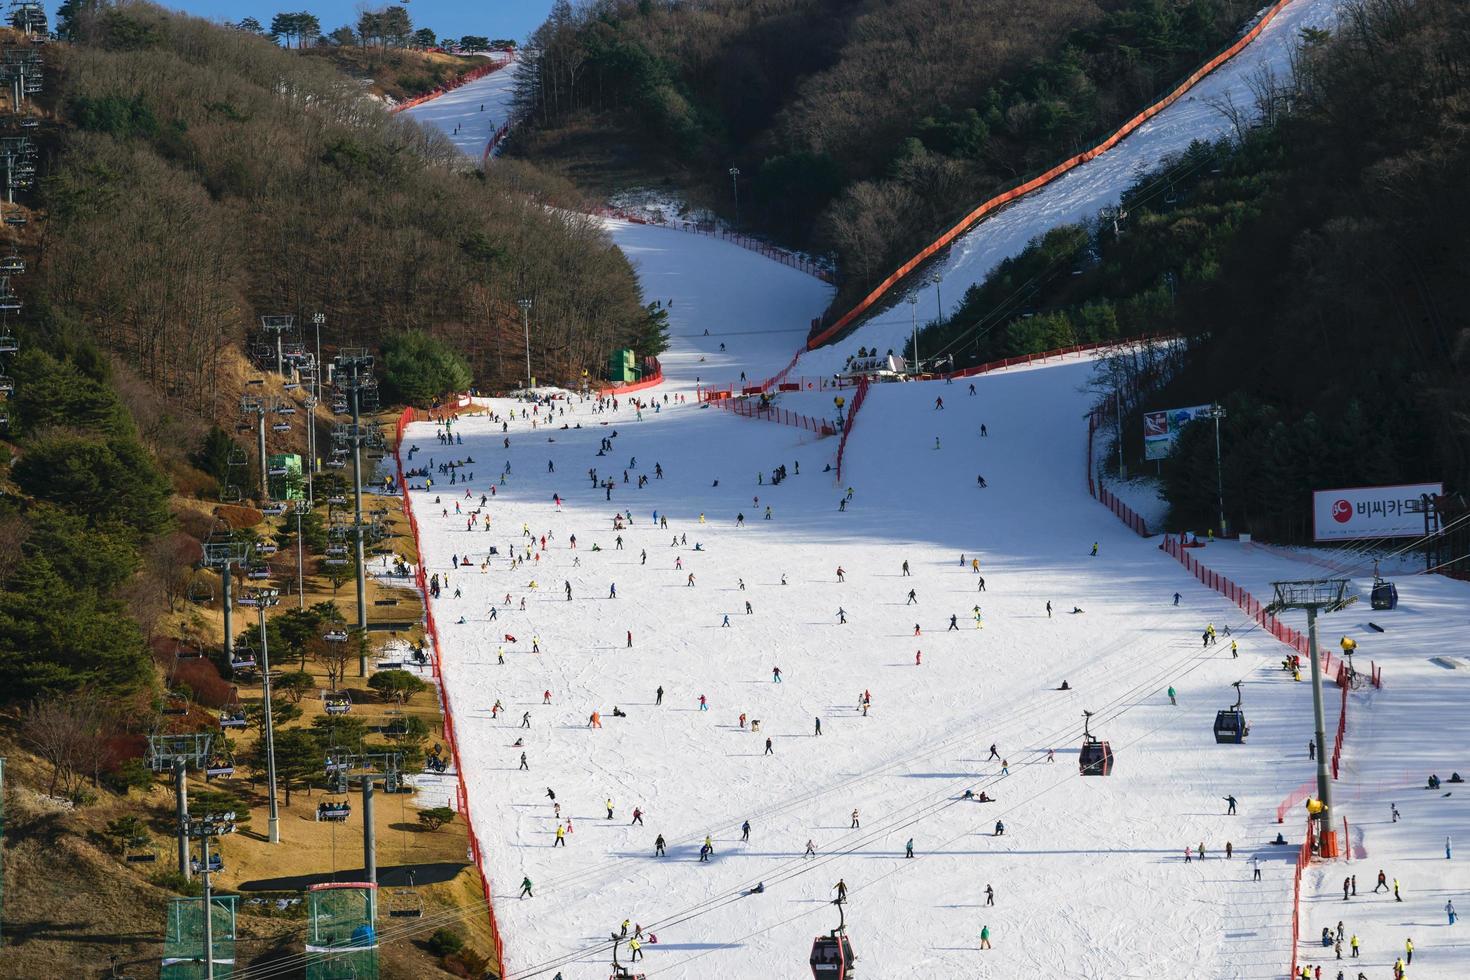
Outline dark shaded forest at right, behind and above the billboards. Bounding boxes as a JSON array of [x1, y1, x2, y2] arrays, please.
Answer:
[[919, 0, 1470, 541]]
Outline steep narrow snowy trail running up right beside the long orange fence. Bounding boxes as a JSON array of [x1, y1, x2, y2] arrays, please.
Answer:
[[801, 0, 1345, 375]]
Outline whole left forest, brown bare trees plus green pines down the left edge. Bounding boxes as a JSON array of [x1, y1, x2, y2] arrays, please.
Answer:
[[0, 3, 663, 704]]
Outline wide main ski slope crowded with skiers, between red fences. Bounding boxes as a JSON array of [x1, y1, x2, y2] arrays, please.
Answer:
[[409, 364, 1346, 977]]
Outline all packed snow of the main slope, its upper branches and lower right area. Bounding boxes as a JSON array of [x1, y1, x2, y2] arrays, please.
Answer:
[[406, 0, 1470, 980]]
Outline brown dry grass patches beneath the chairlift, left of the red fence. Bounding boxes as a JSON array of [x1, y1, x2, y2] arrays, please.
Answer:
[[0, 411, 494, 977]]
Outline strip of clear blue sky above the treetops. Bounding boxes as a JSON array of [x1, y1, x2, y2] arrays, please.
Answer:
[[51, 0, 551, 41]]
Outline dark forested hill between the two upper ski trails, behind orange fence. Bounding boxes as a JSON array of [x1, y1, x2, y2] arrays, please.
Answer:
[[517, 0, 1257, 306]]
